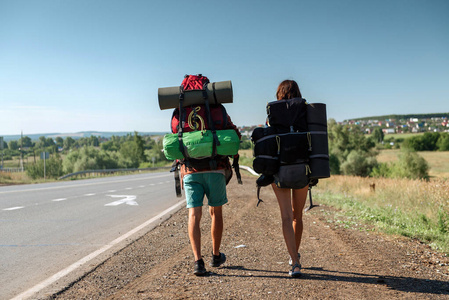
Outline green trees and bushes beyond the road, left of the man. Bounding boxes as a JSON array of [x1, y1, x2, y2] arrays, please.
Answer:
[[3, 132, 168, 179]]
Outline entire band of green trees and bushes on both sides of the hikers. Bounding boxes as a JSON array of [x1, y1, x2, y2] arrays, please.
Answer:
[[3, 119, 440, 178]]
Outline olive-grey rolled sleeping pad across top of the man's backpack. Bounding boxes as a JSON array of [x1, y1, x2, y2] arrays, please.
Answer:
[[157, 80, 233, 110]]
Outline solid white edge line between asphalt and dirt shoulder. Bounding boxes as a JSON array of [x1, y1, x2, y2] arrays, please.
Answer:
[[11, 201, 185, 300]]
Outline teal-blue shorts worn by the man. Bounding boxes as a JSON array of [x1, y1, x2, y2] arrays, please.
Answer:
[[183, 172, 228, 208]]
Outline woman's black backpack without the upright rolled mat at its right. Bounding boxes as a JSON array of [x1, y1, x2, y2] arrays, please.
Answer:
[[251, 98, 311, 189]]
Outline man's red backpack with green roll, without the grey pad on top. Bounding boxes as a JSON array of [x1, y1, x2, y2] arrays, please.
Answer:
[[164, 74, 241, 196]]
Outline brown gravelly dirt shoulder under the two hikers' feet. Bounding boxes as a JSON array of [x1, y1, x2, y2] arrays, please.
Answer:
[[51, 176, 449, 299]]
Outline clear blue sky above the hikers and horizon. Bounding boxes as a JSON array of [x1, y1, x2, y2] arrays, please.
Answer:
[[0, 0, 449, 136]]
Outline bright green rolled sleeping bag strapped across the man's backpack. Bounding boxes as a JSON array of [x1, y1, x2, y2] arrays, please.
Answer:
[[163, 129, 240, 160]]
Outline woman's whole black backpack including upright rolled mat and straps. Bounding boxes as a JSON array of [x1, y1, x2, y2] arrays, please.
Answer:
[[251, 98, 330, 207]]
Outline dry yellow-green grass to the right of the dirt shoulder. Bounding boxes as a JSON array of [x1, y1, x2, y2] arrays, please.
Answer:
[[313, 175, 449, 254]]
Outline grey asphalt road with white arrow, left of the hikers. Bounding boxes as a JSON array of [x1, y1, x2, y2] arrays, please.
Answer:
[[0, 171, 183, 299]]
